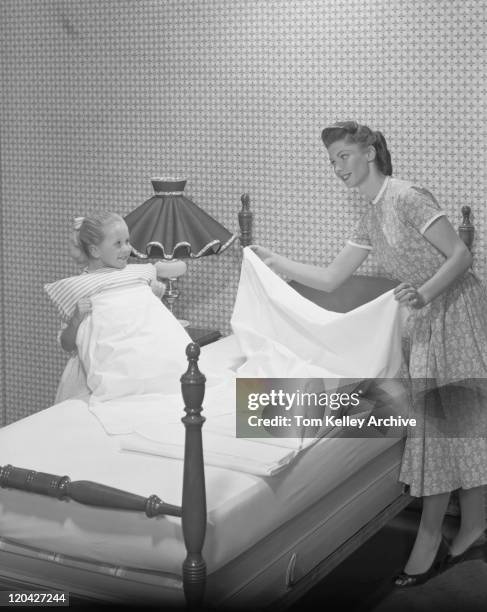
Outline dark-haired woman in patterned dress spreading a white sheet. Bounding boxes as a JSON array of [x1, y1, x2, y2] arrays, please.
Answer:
[[253, 122, 487, 587]]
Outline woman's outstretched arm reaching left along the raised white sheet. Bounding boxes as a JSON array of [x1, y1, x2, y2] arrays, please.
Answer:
[[251, 244, 370, 291]]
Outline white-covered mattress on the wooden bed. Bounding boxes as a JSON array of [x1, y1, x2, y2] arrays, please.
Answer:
[[0, 336, 402, 576]]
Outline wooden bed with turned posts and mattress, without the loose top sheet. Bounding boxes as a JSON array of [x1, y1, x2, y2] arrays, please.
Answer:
[[0, 199, 474, 608]]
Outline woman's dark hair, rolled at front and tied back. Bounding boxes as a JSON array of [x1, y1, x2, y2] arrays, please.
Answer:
[[321, 121, 392, 176]]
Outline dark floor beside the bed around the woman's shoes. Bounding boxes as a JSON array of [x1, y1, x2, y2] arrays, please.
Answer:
[[290, 508, 487, 612]]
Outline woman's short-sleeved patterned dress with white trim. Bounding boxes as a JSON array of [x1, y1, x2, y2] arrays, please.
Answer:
[[349, 178, 487, 496]]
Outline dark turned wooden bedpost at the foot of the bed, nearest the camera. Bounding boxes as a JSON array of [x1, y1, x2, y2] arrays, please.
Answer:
[[181, 343, 206, 608]]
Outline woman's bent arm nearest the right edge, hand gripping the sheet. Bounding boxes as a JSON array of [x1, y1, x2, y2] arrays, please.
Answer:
[[394, 217, 472, 308]]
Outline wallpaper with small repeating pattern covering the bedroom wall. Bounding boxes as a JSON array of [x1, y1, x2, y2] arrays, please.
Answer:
[[0, 0, 487, 422]]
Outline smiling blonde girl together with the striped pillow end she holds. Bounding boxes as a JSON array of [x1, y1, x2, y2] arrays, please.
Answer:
[[45, 212, 165, 403]]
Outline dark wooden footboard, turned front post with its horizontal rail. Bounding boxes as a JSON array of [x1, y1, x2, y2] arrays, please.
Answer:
[[0, 343, 206, 606]]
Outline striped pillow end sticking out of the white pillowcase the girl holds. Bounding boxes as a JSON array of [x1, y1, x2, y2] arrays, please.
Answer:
[[44, 263, 156, 321]]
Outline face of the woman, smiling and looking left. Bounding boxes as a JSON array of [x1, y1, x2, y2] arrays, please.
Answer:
[[328, 139, 375, 187]]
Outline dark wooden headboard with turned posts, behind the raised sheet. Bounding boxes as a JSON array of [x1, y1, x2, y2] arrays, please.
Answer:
[[238, 193, 475, 312]]
